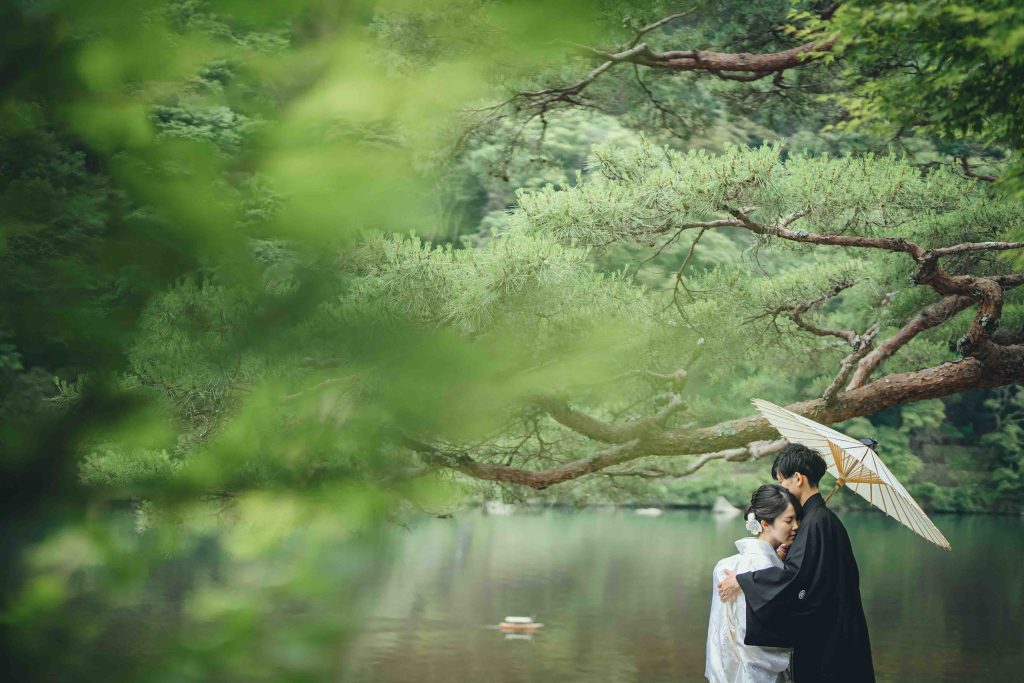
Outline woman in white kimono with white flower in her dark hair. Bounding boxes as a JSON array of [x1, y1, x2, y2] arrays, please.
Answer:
[[705, 483, 800, 683]]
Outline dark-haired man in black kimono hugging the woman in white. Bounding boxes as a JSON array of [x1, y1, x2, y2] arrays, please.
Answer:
[[718, 443, 874, 683]]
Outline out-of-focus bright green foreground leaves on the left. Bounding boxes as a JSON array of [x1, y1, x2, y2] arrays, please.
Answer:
[[0, 0, 606, 681]]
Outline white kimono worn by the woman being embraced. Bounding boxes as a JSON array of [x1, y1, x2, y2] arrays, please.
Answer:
[[705, 538, 793, 683]]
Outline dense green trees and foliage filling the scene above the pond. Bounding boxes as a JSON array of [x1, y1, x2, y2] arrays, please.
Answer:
[[0, 0, 1024, 678]]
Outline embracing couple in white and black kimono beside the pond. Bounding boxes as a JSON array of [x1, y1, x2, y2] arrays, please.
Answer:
[[705, 443, 874, 683]]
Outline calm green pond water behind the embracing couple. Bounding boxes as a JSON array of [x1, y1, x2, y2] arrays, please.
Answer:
[[340, 510, 1024, 683]]
